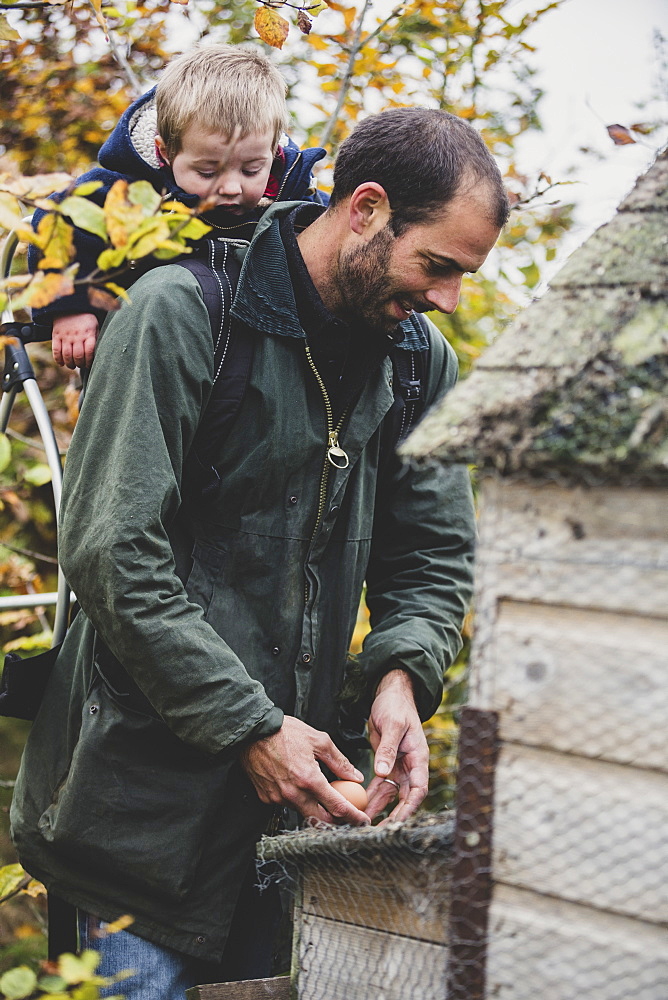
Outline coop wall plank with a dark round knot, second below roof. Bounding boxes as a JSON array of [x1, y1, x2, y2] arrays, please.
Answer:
[[476, 601, 668, 771]]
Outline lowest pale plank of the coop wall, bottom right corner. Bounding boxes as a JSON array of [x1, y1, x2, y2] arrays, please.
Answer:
[[486, 885, 668, 1000]]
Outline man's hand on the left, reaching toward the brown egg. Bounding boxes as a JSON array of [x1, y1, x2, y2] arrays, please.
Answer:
[[240, 715, 368, 826]]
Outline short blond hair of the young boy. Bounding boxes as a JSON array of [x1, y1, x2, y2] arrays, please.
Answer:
[[155, 45, 288, 158]]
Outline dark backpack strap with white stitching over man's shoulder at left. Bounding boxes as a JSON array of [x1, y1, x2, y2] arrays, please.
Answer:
[[176, 240, 253, 493]]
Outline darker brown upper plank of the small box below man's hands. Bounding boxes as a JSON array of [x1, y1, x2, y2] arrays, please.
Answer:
[[302, 851, 451, 944]]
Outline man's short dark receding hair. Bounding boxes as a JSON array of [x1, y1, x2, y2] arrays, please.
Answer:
[[330, 108, 509, 236]]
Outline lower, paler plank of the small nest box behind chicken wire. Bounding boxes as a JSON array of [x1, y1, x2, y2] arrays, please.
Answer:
[[298, 913, 448, 1000]]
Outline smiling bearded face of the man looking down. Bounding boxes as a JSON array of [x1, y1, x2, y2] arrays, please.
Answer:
[[336, 189, 499, 332]]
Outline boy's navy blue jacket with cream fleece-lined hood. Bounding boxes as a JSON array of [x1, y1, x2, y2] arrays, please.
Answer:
[[28, 87, 329, 325]]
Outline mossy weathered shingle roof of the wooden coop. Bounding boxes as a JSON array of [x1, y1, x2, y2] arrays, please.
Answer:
[[402, 150, 668, 483]]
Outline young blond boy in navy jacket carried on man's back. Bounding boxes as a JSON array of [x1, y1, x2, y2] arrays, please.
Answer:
[[29, 45, 327, 368]]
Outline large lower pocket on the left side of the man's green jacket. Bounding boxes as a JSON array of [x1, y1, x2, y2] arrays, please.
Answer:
[[39, 678, 234, 902]]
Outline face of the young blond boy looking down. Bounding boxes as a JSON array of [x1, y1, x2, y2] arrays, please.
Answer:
[[156, 124, 274, 215]]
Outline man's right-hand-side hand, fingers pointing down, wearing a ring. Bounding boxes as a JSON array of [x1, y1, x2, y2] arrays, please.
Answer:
[[366, 670, 429, 821]]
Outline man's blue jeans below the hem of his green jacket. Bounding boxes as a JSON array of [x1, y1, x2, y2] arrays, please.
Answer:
[[79, 866, 281, 1000]]
